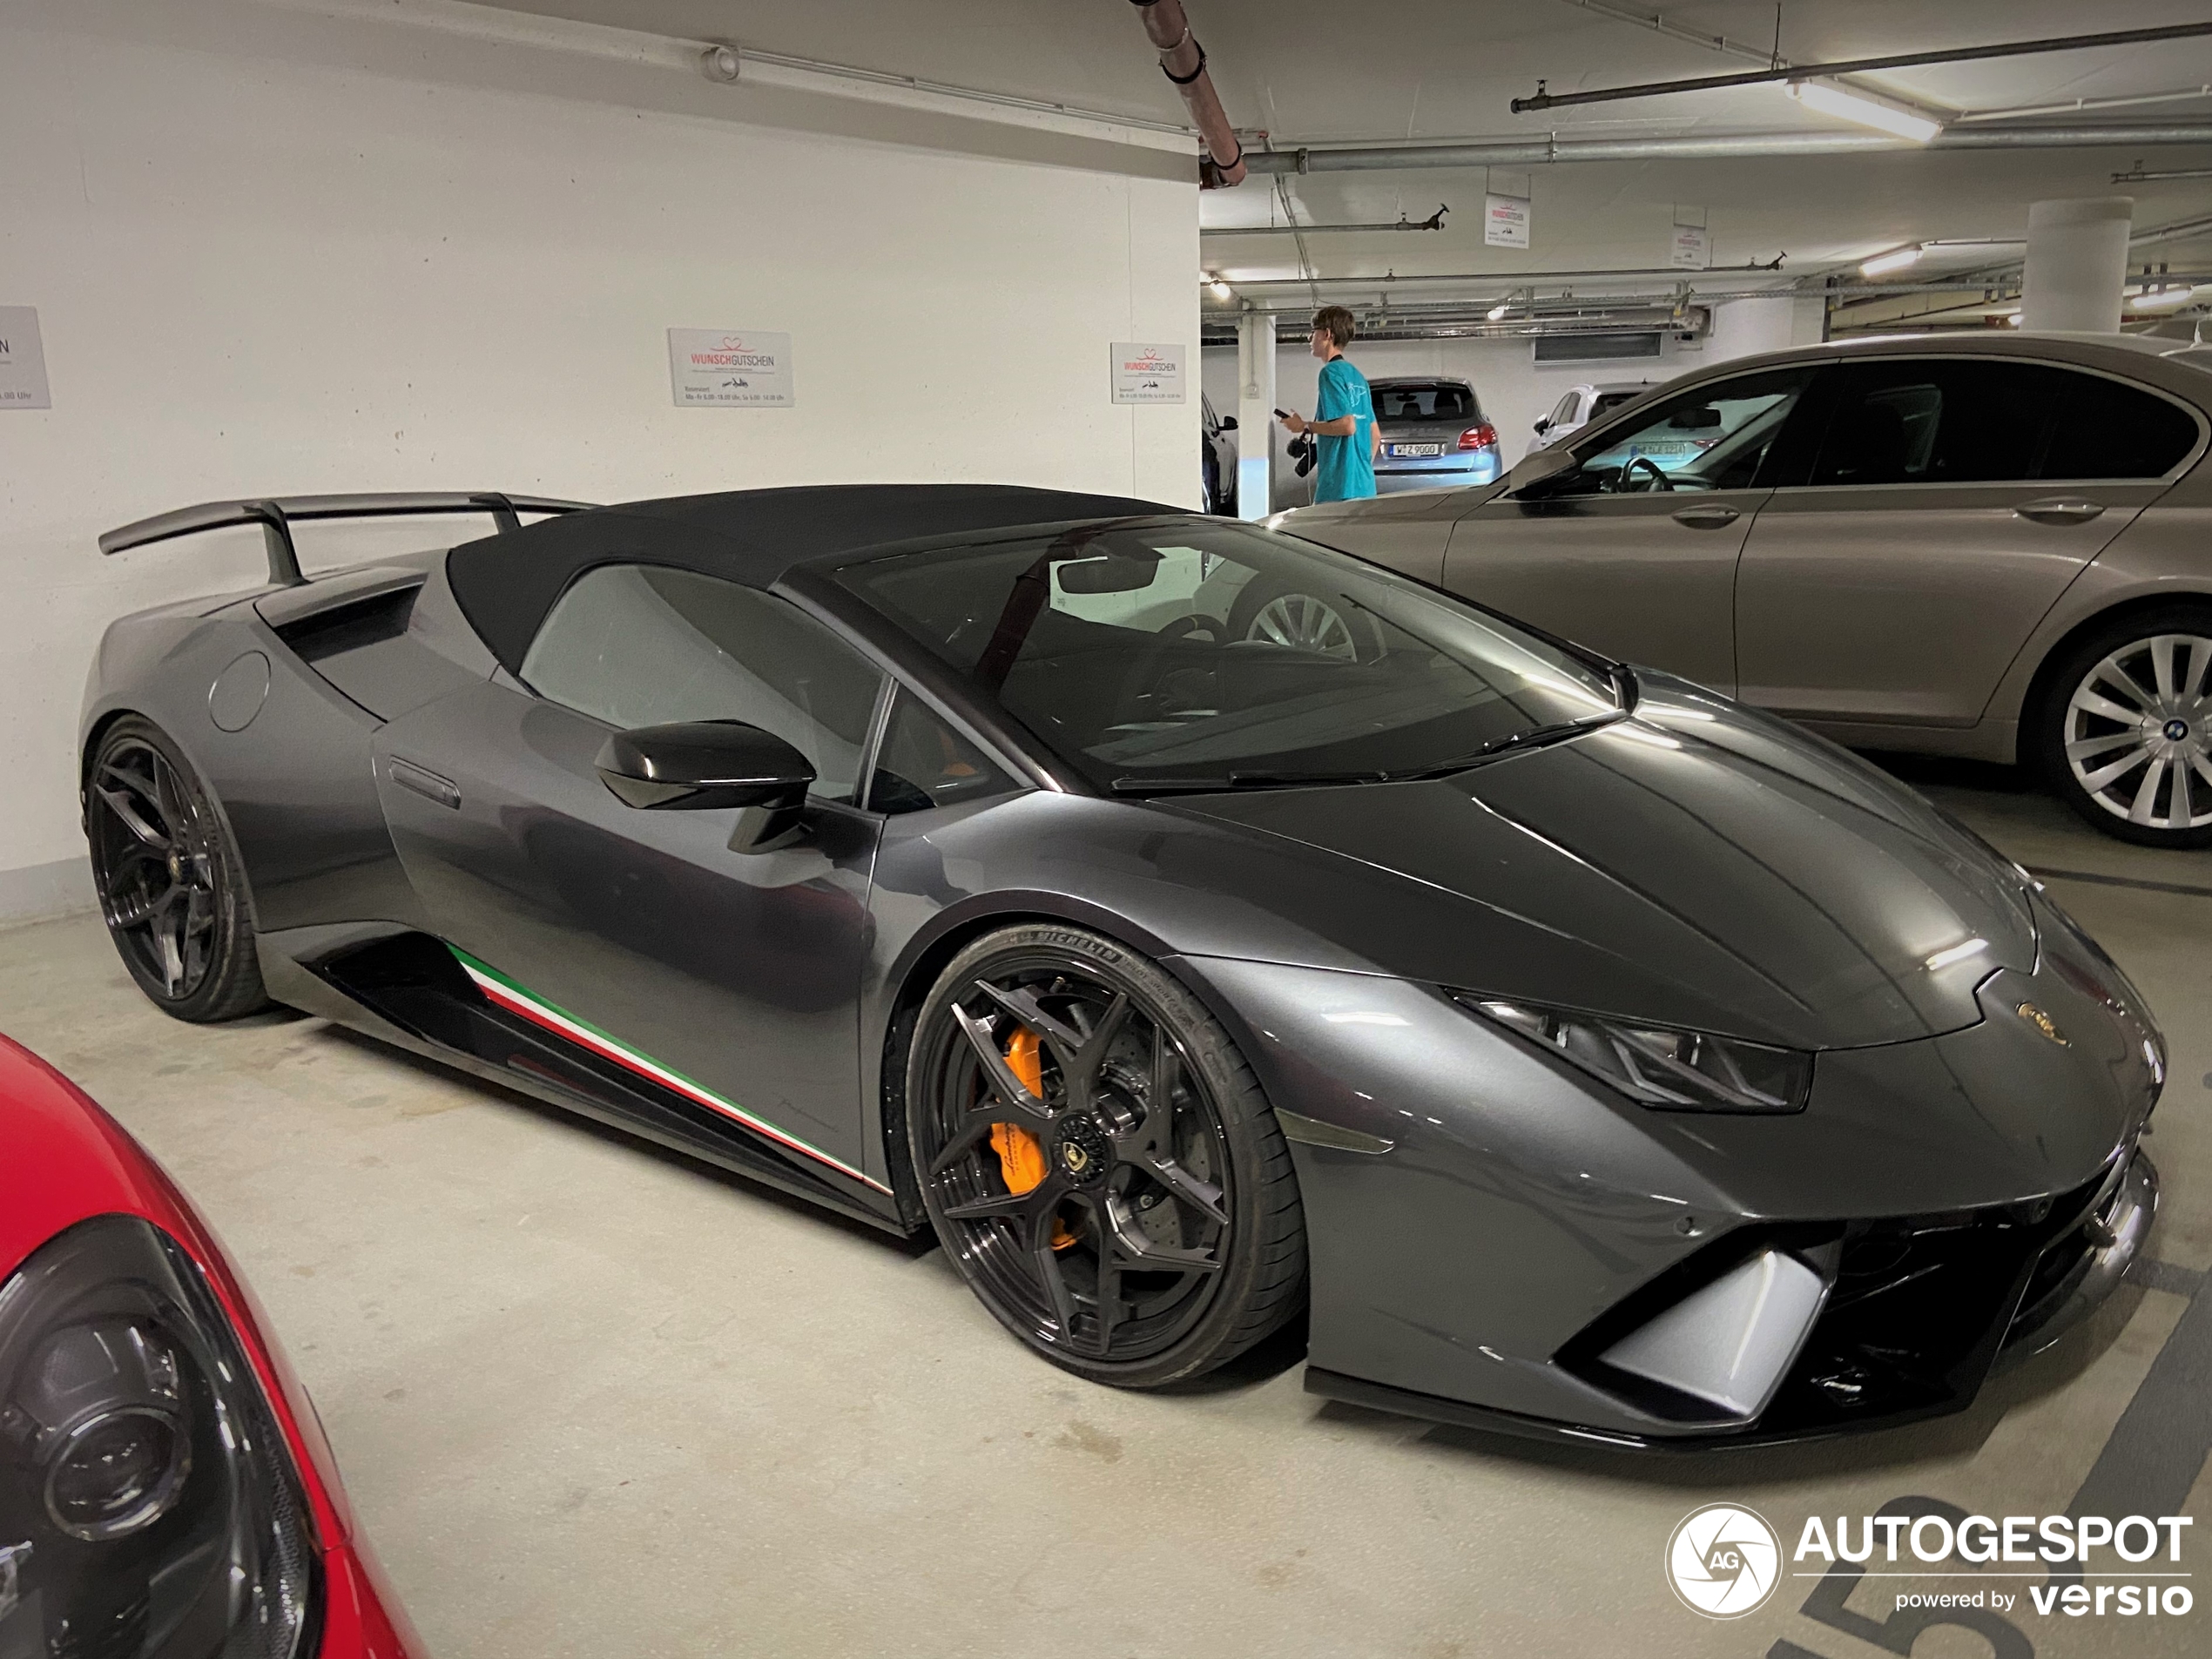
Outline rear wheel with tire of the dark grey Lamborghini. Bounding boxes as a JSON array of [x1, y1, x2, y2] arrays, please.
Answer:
[[84, 714, 270, 1024]]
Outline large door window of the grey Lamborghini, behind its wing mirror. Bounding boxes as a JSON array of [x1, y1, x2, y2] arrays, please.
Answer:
[[522, 564, 882, 800]]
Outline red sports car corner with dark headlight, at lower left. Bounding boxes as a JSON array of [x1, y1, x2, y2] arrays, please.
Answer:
[[0, 1037, 422, 1659]]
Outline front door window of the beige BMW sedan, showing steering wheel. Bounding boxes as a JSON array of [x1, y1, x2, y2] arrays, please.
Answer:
[[1546, 368, 1814, 496]]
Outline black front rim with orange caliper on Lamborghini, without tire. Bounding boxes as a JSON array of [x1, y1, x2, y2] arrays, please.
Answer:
[[921, 964, 1230, 1363]]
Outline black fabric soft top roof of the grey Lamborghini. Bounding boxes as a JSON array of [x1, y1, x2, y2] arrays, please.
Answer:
[[445, 484, 1188, 672]]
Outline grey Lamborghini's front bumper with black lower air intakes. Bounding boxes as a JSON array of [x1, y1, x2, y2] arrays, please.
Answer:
[[1177, 889, 2163, 1447]]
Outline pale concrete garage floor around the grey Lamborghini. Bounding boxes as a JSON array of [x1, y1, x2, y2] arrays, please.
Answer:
[[0, 765, 2212, 1659]]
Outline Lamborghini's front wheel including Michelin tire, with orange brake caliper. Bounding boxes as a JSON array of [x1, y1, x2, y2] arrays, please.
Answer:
[[907, 925, 1305, 1389]]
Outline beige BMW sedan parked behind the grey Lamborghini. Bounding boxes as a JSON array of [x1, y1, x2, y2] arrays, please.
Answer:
[[1283, 334, 2212, 847]]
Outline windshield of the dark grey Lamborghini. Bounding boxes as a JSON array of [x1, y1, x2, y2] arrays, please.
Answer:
[[836, 520, 1619, 794]]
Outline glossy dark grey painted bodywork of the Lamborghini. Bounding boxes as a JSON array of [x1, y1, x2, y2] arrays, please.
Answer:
[[82, 486, 2163, 1445]]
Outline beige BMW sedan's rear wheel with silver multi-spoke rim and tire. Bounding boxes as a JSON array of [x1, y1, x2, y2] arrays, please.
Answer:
[[2031, 602, 2212, 847]]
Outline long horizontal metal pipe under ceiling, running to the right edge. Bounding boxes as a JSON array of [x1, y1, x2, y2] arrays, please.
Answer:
[[1248, 122, 2212, 172]]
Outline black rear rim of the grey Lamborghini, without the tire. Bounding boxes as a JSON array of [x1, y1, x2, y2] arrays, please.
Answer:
[[91, 741, 221, 1002]]
